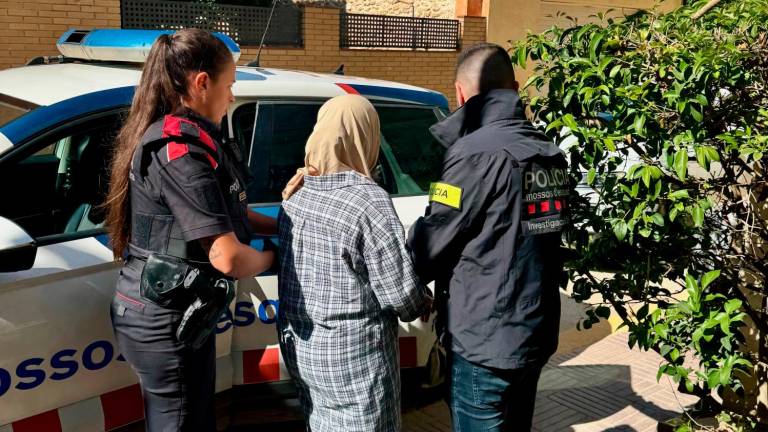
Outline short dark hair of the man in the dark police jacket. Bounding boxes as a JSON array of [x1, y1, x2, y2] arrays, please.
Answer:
[[456, 43, 515, 93]]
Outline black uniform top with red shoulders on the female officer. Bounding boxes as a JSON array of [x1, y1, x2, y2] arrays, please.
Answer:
[[118, 111, 252, 308]]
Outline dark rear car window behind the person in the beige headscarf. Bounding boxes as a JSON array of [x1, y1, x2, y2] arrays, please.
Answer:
[[237, 101, 445, 203]]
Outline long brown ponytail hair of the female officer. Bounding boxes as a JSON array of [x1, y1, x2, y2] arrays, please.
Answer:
[[104, 29, 233, 259]]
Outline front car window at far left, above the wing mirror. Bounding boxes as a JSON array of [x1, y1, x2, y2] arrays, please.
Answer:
[[0, 115, 120, 238]]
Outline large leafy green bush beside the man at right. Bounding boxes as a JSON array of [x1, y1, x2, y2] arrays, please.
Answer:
[[512, 0, 768, 422]]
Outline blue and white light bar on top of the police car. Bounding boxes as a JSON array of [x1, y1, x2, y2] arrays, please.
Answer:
[[56, 29, 240, 63]]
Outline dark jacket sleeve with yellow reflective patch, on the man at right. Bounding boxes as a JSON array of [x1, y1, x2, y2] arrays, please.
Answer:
[[408, 148, 514, 283]]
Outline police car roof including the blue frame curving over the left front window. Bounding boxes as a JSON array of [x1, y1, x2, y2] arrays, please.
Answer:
[[0, 62, 448, 149]]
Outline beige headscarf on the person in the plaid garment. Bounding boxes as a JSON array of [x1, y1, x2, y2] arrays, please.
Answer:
[[283, 95, 381, 199]]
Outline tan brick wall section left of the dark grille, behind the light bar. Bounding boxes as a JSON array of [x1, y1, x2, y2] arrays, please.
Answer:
[[0, 0, 120, 69]]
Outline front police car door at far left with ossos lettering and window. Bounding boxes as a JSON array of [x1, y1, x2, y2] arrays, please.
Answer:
[[0, 112, 146, 425]]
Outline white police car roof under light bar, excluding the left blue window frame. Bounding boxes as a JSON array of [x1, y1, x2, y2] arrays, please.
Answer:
[[0, 62, 448, 108]]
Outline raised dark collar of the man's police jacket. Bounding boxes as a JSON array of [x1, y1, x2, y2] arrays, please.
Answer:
[[430, 89, 525, 147]]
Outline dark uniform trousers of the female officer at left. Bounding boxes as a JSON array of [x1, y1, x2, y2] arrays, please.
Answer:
[[112, 284, 216, 432]]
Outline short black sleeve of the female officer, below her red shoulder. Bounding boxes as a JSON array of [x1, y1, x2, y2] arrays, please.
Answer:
[[161, 146, 234, 241]]
